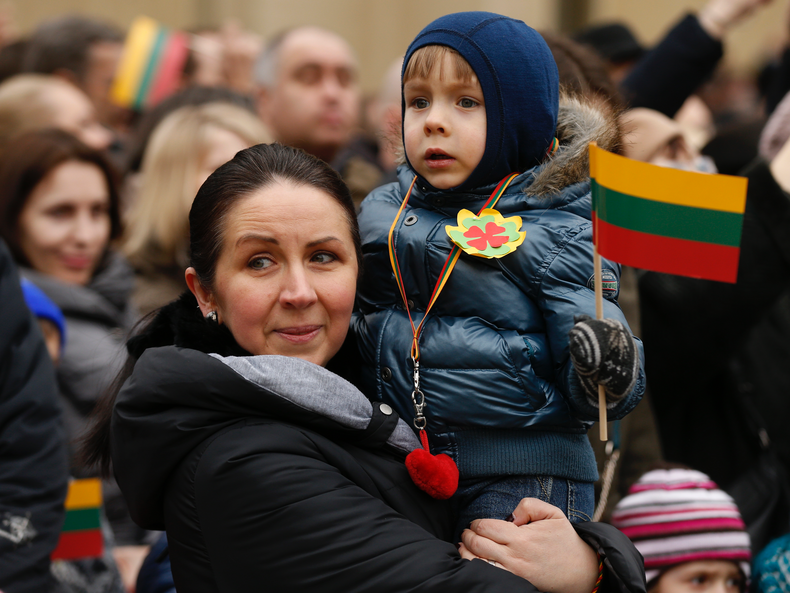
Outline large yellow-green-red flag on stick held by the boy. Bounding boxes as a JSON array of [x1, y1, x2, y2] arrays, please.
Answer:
[[590, 144, 747, 282]]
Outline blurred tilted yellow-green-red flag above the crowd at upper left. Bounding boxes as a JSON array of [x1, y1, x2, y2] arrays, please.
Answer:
[[110, 16, 189, 110]]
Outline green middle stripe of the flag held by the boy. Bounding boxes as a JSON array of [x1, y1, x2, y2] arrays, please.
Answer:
[[592, 179, 743, 247]]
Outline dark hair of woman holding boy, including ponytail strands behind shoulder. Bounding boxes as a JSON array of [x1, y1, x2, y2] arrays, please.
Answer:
[[81, 144, 362, 476]]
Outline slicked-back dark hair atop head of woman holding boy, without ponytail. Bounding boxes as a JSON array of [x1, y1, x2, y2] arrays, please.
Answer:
[[189, 143, 362, 289]]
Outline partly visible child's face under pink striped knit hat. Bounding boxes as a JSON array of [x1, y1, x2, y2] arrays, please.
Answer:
[[651, 560, 744, 593]]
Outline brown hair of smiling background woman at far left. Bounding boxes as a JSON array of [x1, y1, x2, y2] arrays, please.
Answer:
[[0, 129, 121, 266]]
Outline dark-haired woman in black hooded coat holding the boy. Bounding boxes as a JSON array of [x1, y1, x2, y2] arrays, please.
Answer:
[[88, 10, 644, 593]]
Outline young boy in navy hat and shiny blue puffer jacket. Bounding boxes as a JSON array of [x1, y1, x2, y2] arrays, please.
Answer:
[[352, 12, 644, 530]]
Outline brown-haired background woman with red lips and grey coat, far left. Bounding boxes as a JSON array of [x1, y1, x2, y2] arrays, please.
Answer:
[[0, 129, 135, 591]]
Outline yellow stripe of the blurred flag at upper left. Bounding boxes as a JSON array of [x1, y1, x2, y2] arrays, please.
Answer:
[[110, 16, 159, 107]]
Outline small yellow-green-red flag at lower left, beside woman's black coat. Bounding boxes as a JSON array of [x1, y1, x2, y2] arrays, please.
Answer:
[[52, 478, 104, 560]]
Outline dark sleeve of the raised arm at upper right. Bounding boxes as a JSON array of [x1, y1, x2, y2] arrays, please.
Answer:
[[621, 15, 724, 117]]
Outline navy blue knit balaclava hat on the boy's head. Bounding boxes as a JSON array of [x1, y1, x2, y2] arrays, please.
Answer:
[[401, 12, 559, 189]]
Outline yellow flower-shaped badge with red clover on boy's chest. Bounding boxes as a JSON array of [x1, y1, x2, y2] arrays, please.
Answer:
[[444, 208, 527, 259]]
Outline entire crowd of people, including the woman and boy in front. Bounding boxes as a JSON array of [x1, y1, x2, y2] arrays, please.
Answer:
[[0, 0, 790, 593]]
